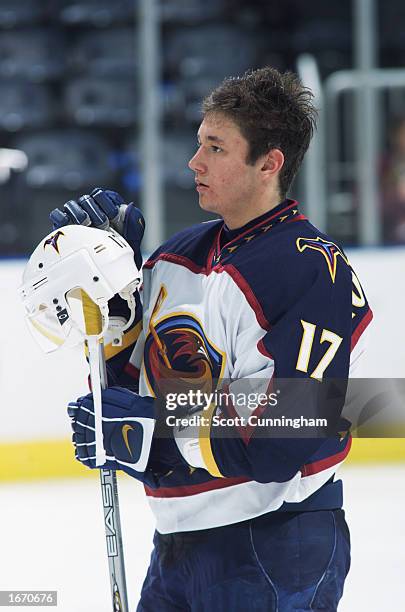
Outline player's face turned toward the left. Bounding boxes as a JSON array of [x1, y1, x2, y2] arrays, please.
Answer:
[[188, 114, 262, 227]]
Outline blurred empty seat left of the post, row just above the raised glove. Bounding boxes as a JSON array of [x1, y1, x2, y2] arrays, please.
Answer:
[[14, 130, 114, 190]]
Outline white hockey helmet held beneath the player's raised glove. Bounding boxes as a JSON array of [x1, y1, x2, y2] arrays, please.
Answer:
[[20, 225, 141, 352]]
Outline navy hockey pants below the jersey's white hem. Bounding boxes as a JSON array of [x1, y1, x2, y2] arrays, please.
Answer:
[[137, 510, 350, 612]]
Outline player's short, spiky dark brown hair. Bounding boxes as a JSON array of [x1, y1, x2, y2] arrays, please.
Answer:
[[203, 66, 317, 197]]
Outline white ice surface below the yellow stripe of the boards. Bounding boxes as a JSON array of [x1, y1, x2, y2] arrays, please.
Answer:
[[0, 465, 405, 612]]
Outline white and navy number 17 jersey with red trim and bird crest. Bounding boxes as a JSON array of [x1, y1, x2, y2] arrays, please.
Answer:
[[119, 200, 372, 533]]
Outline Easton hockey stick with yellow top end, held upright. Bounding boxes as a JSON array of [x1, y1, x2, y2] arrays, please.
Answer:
[[81, 290, 128, 612]]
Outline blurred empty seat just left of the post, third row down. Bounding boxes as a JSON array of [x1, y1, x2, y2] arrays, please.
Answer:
[[64, 78, 138, 127]]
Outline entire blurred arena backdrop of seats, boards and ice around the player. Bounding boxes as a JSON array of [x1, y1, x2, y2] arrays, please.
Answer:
[[0, 0, 405, 612]]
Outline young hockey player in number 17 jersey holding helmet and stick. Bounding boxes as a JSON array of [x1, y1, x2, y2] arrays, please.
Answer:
[[52, 68, 372, 612]]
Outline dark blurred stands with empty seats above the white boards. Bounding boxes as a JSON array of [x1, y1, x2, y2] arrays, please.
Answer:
[[0, 0, 405, 251]]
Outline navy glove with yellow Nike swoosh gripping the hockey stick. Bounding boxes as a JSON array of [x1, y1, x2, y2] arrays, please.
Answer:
[[68, 387, 156, 486]]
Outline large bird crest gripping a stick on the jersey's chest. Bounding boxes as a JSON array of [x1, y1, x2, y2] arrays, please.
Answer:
[[144, 285, 225, 397]]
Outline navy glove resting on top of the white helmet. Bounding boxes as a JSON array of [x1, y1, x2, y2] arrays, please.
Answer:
[[49, 187, 145, 268]]
